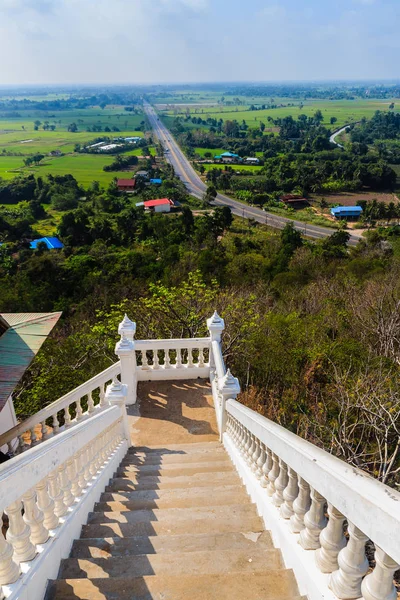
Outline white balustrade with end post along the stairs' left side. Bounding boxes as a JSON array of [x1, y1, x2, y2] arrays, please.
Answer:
[[0, 404, 129, 599]]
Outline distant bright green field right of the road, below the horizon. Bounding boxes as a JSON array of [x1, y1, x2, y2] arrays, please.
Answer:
[[160, 99, 400, 127]]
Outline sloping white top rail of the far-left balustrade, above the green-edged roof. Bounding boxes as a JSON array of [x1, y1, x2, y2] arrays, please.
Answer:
[[0, 362, 121, 448]]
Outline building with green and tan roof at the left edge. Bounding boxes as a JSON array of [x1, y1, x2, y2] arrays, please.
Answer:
[[0, 312, 62, 452]]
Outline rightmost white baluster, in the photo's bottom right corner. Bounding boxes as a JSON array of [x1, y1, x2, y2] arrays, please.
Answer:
[[361, 546, 400, 600]]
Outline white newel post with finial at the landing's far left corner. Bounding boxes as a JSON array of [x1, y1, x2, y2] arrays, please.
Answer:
[[115, 315, 137, 405]]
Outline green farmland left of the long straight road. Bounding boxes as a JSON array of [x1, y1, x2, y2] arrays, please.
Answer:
[[0, 98, 149, 187]]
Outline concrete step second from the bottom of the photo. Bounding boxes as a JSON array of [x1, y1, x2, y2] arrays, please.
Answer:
[[59, 548, 284, 579]]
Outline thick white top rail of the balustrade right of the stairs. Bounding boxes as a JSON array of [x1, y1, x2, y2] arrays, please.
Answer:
[[226, 400, 400, 562]]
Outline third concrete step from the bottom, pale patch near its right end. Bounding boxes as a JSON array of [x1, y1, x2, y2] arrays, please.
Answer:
[[71, 530, 274, 558]]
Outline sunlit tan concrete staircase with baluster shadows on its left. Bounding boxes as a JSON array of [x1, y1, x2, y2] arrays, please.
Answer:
[[46, 440, 299, 600]]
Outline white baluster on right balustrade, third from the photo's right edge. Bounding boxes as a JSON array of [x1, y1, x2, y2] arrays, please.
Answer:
[[315, 502, 346, 573]]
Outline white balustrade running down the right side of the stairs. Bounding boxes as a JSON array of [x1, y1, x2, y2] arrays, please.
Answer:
[[222, 398, 400, 600]]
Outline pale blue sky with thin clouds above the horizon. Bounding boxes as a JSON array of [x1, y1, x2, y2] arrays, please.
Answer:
[[0, 0, 400, 85]]
